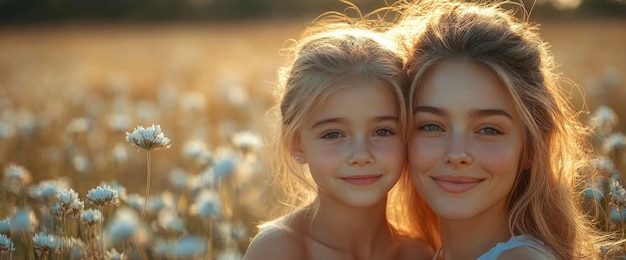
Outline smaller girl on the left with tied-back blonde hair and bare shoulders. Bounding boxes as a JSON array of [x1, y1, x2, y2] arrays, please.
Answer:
[[245, 10, 434, 259]]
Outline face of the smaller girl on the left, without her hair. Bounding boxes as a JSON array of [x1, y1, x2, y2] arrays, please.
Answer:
[[292, 82, 405, 207]]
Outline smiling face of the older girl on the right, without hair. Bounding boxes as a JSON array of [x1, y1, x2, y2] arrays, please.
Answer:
[[409, 61, 523, 220]]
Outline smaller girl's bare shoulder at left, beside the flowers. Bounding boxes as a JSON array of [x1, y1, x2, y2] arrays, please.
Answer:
[[244, 214, 307, 260]]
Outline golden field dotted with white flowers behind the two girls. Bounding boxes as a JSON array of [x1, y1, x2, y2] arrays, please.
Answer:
[[0, 20, 626, 259]]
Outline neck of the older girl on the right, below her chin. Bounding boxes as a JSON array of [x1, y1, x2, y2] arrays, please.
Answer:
[[440, 209, 511, 260]]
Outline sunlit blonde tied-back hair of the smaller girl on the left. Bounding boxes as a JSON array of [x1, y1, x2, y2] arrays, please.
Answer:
[[262, 6, 438, 250]]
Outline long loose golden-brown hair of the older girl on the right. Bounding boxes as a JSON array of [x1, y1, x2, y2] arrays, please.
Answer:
[[395, 0, 605, 259]]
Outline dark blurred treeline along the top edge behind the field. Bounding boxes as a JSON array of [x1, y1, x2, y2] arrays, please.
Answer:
[[0, 0, 626, 24]]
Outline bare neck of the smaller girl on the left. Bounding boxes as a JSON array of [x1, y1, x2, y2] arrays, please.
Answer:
[[310, 195, 391, 259]]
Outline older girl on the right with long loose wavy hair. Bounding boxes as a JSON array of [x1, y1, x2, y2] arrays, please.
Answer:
[[396, 0, 616, 259]]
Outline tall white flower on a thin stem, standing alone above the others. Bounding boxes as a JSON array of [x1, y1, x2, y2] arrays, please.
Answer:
[[126, 125, 171, 219]]
